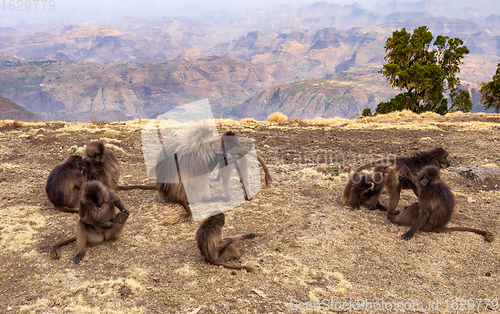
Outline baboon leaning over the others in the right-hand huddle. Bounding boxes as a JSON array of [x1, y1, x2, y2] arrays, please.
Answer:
[[348, 147, 450, 214]]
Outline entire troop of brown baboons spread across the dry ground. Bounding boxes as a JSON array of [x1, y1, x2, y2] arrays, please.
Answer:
[[45, 126, 493, 272]]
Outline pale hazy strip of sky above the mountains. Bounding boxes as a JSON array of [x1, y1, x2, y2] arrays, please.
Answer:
[[0, 0, 500, 26]]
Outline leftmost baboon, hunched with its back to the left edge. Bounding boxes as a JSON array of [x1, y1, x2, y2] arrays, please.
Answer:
[[45, 155, 83, 213]]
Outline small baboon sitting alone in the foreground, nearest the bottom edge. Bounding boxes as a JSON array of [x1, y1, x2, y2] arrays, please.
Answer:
[[196, 213, 258, 273]]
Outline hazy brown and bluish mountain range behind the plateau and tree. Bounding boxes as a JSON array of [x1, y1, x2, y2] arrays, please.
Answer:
[[0, 1, 500, 121]]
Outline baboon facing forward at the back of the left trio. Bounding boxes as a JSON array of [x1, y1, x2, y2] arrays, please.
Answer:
[[83, 141, 120, 190]]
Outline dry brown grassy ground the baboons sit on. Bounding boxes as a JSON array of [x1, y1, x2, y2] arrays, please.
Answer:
[[0, 114, 500, 313]]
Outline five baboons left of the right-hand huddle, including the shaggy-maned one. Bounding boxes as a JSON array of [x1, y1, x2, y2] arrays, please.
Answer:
[[45, 125, 272, 272]]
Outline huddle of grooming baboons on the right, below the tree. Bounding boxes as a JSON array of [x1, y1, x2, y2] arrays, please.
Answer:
[[342, 148, 493, 242]]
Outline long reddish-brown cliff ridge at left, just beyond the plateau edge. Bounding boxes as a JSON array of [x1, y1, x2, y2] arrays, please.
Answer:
[[0, 57, 295, 121]]
